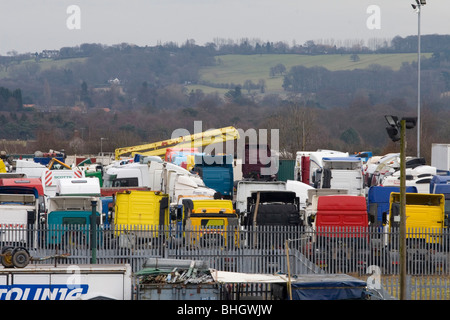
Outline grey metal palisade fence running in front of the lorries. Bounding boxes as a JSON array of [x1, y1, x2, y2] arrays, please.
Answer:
[[0, 225, 450, 299]]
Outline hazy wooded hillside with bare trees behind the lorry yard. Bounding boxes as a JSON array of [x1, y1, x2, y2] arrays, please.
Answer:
[[0, 36, 450, 164]]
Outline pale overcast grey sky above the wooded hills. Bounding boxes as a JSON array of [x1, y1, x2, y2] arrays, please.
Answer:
[[0, 0, 450, 55]]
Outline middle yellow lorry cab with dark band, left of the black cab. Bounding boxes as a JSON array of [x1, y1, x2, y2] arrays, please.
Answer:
[[182, 198, 239, 246]]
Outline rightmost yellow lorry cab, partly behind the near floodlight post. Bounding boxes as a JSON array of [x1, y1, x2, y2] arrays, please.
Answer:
[[389, 192, 448, 243]]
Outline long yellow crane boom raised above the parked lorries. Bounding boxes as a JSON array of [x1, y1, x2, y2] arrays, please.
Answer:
[[115, 127, 239, 160]]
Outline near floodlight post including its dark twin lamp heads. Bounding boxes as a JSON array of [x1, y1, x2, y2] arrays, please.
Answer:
[[385, 115, 417, 300]]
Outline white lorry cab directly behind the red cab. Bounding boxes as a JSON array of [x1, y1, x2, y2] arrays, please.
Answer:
[[313, 157, 364, 196]]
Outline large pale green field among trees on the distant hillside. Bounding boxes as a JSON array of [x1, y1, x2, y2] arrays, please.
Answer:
[[193, 53, 431, 93]]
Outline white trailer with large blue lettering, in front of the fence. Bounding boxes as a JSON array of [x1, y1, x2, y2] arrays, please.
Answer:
[[0, 264, 133, 300]]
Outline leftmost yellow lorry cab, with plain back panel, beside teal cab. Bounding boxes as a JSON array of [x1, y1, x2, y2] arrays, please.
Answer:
[[112, 190, 170, 248]]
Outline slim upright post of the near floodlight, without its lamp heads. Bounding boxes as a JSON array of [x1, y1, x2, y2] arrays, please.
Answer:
[[399, 120, 406, 300]]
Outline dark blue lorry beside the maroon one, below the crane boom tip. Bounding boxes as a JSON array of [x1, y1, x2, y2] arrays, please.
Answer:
[[193, 155, 234, 199]]
